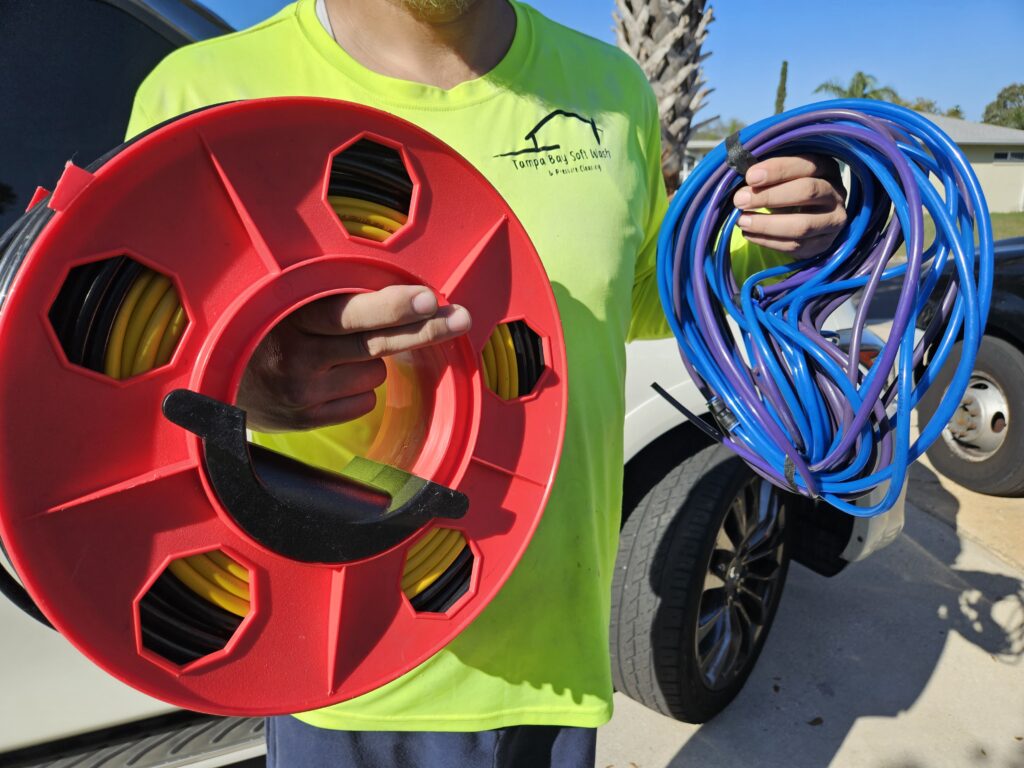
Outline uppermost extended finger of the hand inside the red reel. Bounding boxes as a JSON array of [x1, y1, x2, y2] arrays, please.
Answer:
[[289, 286, 437, 335]]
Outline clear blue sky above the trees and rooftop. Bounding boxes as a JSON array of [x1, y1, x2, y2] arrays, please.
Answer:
[[208, 0, 1024, 123]]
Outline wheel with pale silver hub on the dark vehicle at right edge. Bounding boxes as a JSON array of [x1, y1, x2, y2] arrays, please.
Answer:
[[918, 336, 1024, 496]]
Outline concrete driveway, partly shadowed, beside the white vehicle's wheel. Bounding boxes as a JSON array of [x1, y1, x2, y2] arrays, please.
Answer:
[[597, 463, 1024, 768]]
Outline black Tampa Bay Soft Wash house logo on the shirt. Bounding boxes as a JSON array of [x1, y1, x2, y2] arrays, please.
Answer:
[[495, 110, 611, 176]]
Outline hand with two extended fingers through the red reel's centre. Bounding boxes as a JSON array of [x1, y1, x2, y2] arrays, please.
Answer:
[[238, 286, 471, 432]]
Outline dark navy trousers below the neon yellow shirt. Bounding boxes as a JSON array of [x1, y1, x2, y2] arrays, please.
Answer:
[[266, 717, 597, 768]]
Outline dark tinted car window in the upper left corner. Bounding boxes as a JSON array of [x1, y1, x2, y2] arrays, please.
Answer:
[[0, 0, 174, 231]]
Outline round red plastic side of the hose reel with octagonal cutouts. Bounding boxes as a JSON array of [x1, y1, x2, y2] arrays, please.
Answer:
[[0, 98, 567, 715]]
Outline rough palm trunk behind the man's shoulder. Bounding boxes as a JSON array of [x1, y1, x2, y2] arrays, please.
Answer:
[[614, 0, 714, 191]]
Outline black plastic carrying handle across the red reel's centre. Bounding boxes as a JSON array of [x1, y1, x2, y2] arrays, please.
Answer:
[[162, 389, 469, 564]]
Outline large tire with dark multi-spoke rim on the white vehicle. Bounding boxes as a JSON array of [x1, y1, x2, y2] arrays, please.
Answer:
[[610, 445, 793, 723]]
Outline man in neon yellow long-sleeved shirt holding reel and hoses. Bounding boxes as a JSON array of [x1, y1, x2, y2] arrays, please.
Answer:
[[129, 0, 845, 768]]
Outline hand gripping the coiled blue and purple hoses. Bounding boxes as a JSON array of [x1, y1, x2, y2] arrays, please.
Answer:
[[732, 155, 846, 259]]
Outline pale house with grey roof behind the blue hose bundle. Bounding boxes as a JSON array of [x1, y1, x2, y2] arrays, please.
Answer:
[[684, 114, 1024, 213]]
